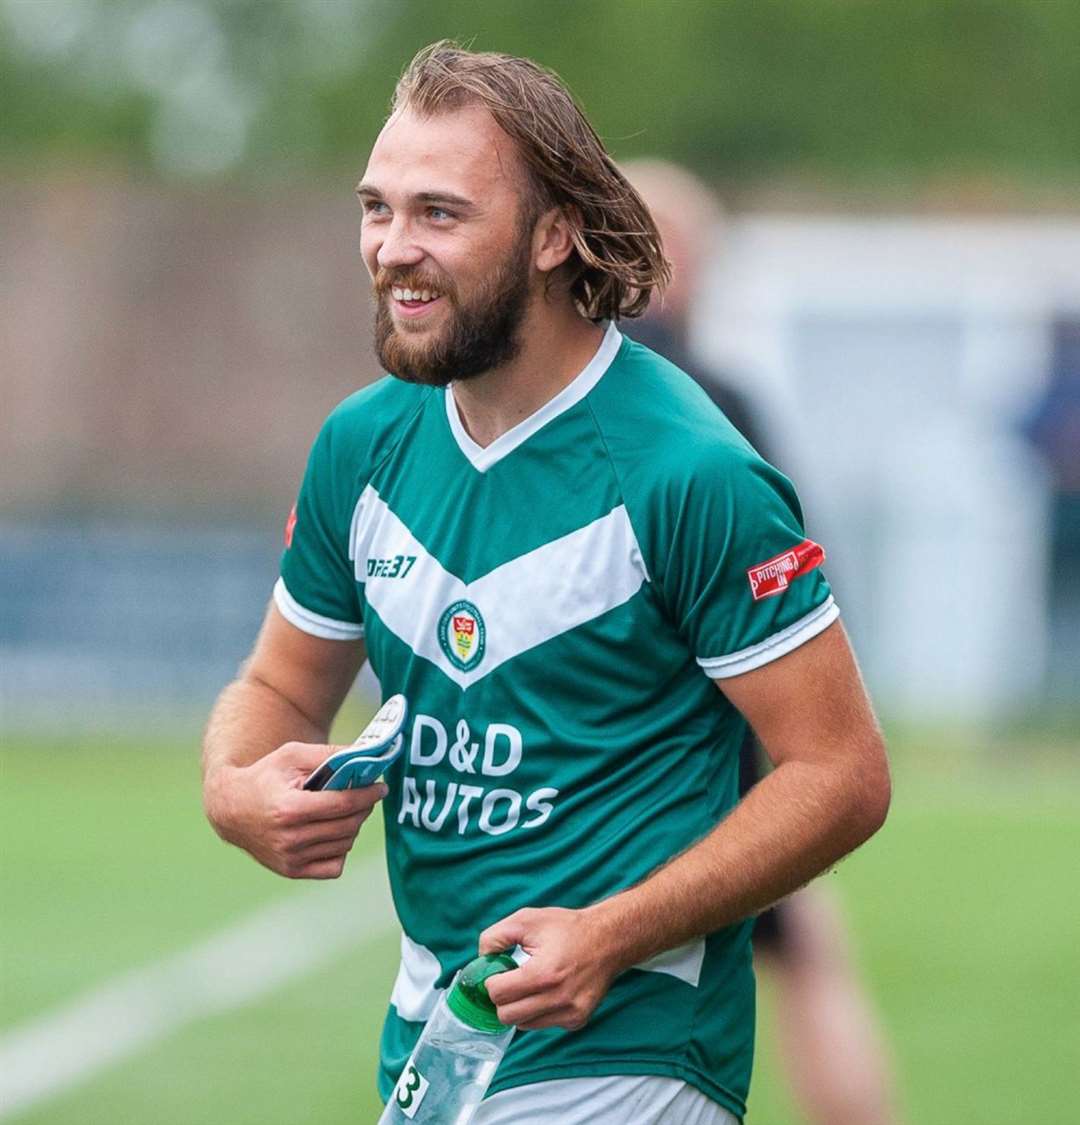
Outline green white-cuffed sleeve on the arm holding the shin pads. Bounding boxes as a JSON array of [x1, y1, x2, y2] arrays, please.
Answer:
[[273, 416, 363, 640]]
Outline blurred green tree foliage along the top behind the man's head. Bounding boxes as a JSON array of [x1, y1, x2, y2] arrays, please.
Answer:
[[0, 0, 1080, 194]]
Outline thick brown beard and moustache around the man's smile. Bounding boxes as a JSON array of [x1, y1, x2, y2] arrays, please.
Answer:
[[375, 228, 531, 387]]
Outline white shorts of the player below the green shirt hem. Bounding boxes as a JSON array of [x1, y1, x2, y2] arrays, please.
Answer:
[[473, 1074, 738, 1125]]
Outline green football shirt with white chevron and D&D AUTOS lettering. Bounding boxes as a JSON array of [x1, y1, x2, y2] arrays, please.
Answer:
[[275, 325, 837, 1116]]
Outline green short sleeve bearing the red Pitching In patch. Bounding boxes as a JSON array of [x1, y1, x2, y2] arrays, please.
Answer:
[[664, 447, 839, 680]]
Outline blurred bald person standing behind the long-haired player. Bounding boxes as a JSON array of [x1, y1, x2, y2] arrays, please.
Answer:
[[621, 160, 897, 1125]]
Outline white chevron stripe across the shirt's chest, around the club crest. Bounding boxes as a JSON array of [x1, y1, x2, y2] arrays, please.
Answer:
[[349, 485, 649, 689]]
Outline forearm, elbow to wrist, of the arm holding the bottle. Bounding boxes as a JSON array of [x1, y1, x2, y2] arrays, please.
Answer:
[[587, 752, 889, 971]]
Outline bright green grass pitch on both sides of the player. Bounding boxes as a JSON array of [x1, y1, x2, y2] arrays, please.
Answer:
[[0, 737, 1080, 1125]]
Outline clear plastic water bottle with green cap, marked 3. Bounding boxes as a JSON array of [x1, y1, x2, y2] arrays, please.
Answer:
[[379, 953, 518, 1125]]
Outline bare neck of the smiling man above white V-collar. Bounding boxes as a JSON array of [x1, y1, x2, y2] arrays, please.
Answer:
[[448, 298, 604, 447]]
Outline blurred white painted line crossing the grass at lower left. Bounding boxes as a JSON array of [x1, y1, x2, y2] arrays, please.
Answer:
[[0, 857, 396, 1118]]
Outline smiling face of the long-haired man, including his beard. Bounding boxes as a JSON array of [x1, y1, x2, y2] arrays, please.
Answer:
[[357, 107, 533, 386]]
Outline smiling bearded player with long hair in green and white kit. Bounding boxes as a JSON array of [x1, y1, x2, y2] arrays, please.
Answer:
[[205, 43, 889, 1125]]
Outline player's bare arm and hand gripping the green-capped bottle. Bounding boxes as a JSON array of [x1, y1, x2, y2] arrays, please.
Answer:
[[480, 622, 890, 1028]]
